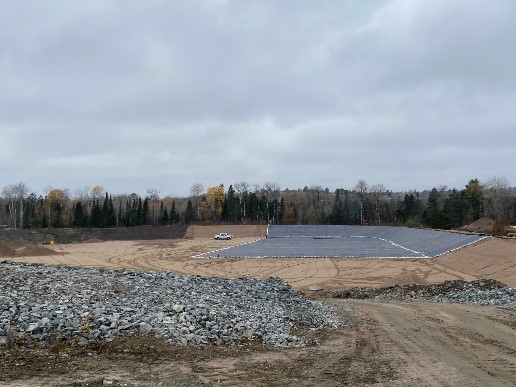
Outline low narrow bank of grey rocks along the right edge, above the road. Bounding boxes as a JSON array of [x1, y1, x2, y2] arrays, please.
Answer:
[[330, 279, 516, 309]]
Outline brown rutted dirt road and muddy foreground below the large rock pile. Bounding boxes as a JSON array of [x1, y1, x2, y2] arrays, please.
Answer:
[[4, 299, 516, 386]]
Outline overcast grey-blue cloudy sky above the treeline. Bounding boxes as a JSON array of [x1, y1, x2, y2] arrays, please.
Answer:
[[0, 0, 516, 196]]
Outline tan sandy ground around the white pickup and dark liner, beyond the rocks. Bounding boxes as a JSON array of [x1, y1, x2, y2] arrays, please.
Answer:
[[4, 226, 516, 290]]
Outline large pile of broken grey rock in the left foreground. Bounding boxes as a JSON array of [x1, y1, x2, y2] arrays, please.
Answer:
[[0, 261, 340, 347]]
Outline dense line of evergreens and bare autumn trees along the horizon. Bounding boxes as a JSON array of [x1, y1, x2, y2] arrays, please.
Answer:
[[0, 177, 516, 231]]
